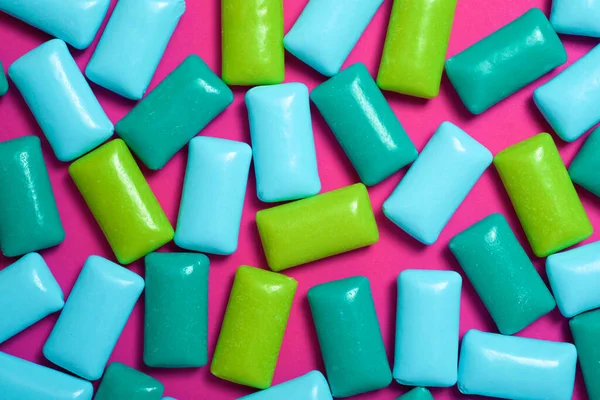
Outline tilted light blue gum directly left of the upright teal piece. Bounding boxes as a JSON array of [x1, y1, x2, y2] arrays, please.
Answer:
[[44, 256, 144, 380]]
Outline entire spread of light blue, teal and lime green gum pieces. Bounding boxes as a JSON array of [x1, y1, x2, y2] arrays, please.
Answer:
[[5, 0, 600, 400]]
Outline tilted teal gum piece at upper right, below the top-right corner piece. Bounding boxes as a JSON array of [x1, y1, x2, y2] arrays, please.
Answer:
[[446, 8, 567, 114]]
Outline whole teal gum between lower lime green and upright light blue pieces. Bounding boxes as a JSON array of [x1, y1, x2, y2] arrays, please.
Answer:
[[308, 276, 392, 397]]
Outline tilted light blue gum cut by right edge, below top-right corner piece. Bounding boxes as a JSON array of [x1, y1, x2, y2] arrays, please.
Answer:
[[533, 46, 600, 142]]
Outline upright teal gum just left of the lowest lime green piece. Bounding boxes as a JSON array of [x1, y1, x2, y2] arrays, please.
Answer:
[[144, 253, 209, 368]]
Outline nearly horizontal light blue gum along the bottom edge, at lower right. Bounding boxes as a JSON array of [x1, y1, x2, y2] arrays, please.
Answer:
[[458, 329, 577, 400]]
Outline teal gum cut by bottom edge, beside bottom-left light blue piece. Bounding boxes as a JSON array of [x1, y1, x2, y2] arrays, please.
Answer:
[[94, 362, 165, 400]]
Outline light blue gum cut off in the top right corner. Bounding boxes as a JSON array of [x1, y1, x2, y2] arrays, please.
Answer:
[[550, 0, 600, 37]]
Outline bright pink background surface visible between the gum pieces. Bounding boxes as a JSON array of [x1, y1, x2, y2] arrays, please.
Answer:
[[0, 0, 600, 400]]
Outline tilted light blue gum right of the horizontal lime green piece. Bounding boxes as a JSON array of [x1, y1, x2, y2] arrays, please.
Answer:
[[383, 122, 493, 244]]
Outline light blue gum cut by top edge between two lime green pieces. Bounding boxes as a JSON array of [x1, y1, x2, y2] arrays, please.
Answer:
[[283, 0, 383, 76]]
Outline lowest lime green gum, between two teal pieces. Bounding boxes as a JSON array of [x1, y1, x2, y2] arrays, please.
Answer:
[[210, 266, 298, 389]]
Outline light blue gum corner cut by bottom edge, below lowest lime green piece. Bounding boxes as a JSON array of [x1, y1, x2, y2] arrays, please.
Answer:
[[238, 371, 333, 400]]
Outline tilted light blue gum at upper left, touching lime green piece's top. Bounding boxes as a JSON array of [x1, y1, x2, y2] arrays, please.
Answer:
[[8, 39, 114, 161]]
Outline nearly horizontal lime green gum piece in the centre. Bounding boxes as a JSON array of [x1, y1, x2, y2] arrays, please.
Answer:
[[256, 183, 379, 271]]
